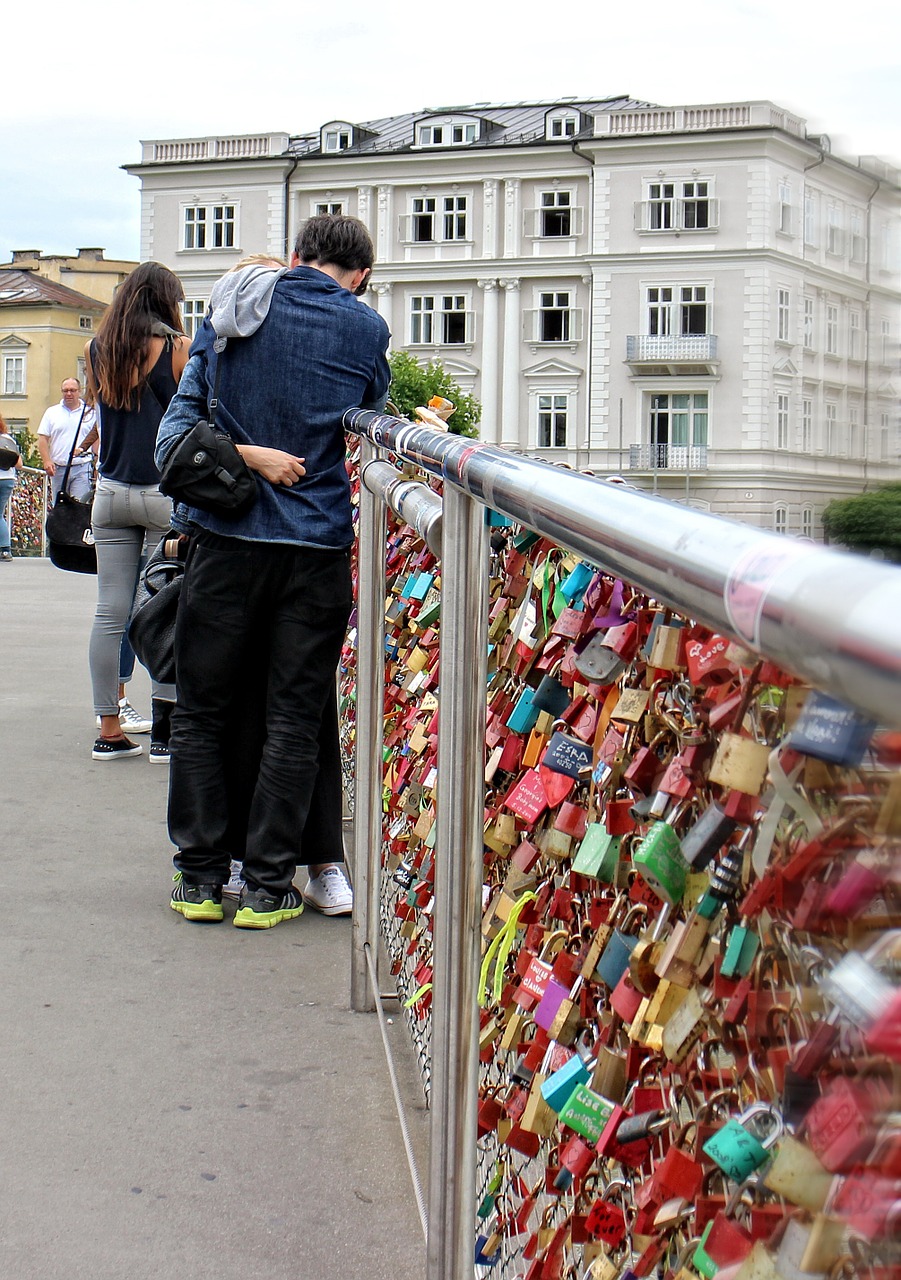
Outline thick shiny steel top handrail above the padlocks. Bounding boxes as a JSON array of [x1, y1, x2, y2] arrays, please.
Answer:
[[344, 410, 901, 727]]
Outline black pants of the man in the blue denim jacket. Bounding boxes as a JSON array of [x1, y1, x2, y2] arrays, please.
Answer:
[[169, 531, 352, 892]]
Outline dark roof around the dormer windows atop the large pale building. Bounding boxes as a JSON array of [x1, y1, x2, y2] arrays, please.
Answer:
[[288, 96, 654, 159]]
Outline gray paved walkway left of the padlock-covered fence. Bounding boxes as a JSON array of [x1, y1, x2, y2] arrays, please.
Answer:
[[0, 561, 427, 1280]]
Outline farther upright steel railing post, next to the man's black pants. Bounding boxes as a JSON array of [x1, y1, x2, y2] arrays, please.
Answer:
[[351, 440, 388, 1012]]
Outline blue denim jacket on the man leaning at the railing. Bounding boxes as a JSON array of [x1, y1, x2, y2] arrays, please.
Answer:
[[156, 266, 390, 549]]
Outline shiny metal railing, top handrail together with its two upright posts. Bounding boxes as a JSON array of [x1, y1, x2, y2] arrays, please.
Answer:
[[344, 410, 901, 1280]]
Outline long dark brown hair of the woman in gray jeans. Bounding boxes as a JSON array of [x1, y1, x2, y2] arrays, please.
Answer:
[[91, 262, 184, 408]]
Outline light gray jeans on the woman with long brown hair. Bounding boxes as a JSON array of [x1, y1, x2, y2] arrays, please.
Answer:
[[90, 477, 175, 716]]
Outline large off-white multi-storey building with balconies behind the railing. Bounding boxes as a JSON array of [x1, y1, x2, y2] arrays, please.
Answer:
[[125, 99, 901, 538]]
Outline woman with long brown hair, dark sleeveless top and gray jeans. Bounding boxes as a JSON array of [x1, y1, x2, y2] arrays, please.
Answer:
[[84, 262, 189, 764]]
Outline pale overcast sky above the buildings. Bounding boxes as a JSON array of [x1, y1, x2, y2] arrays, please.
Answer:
[[0, 0, 901, 261]]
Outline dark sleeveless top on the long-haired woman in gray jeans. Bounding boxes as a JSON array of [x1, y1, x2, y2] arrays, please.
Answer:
[[91, 338, 178, 484]]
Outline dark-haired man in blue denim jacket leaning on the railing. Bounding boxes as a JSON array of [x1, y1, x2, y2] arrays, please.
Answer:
[[156, 215, 390, 928]]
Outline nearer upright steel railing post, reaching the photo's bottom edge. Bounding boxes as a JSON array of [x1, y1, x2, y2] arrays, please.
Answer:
[[426, 485, 488, 1280]]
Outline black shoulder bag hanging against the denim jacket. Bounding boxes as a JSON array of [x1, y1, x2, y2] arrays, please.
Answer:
[[160, 338, 257, 520]]
